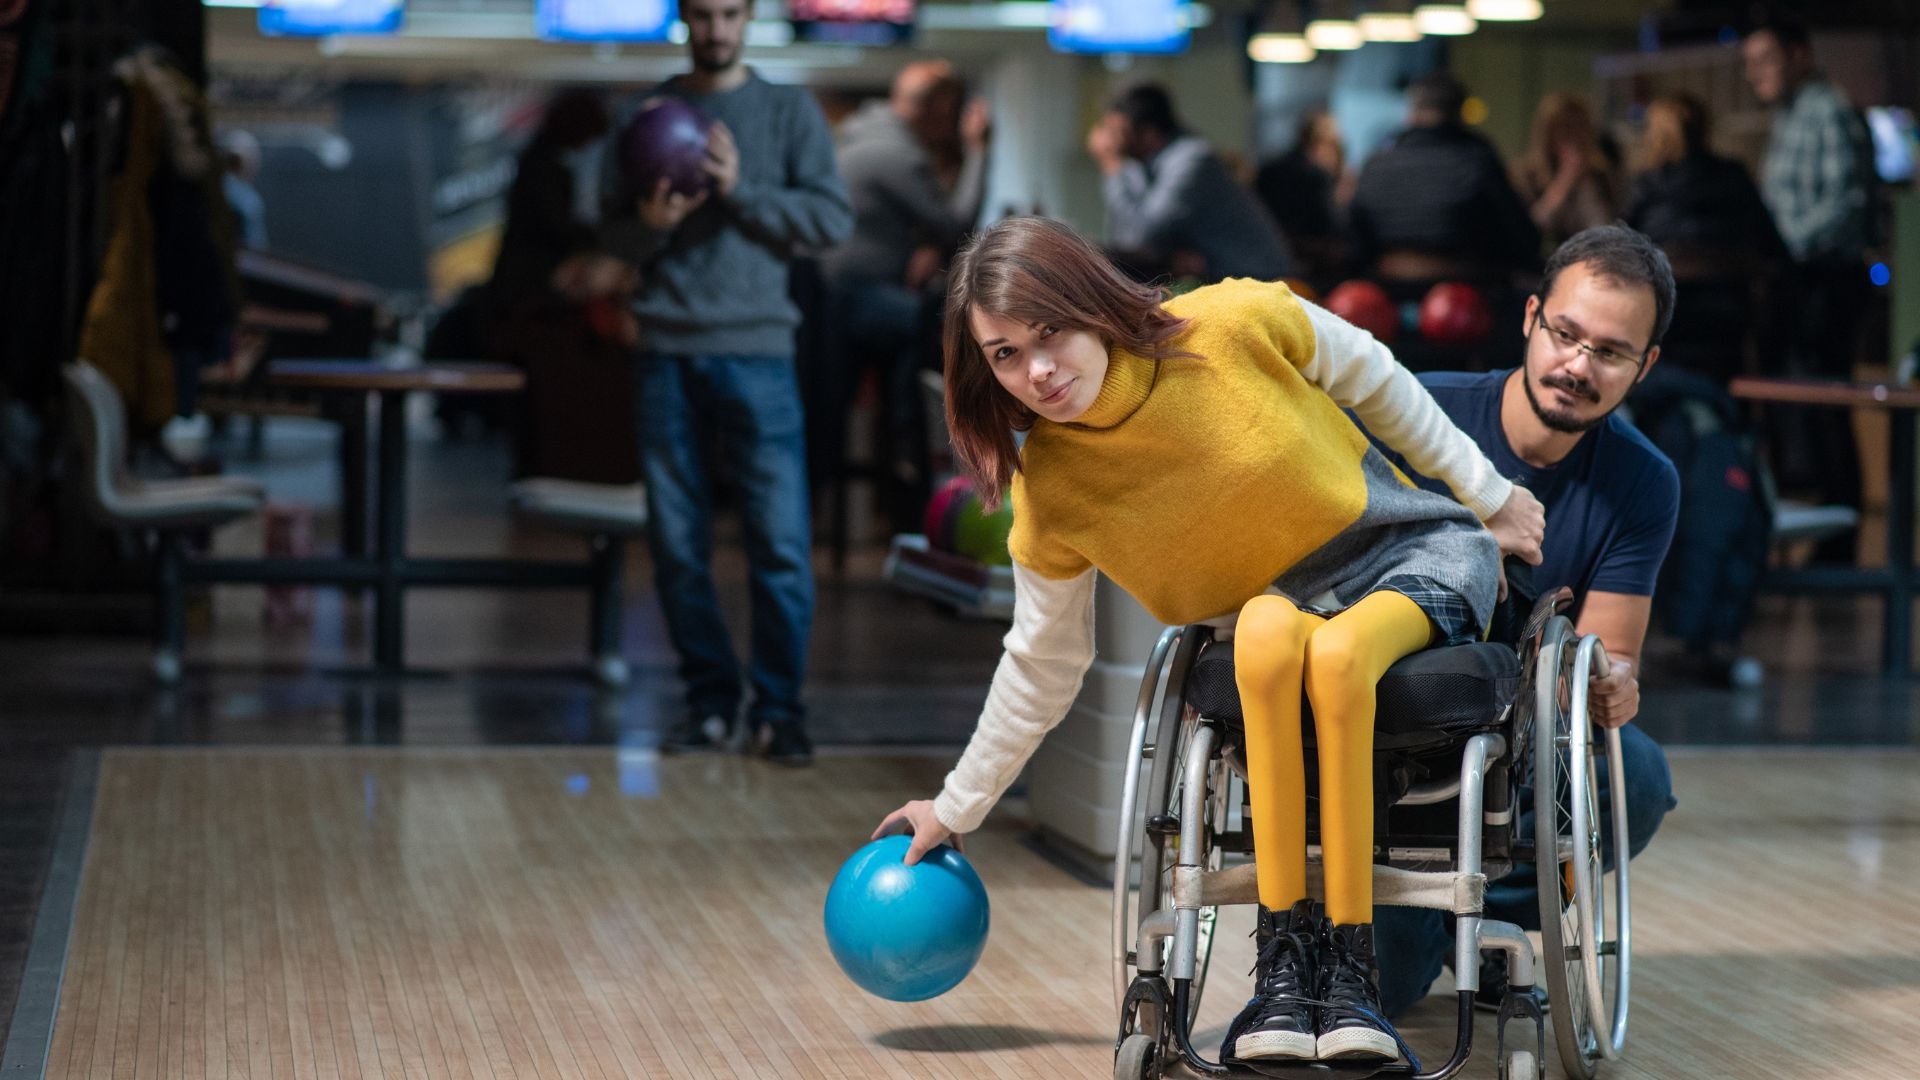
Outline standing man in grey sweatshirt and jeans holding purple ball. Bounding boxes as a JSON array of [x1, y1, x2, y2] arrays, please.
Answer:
[[603, 0, 852, 765]]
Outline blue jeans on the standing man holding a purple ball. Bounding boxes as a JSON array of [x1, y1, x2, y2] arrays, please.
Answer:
[[634, 354, 814, 726]]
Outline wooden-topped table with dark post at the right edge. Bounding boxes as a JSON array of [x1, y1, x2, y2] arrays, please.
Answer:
[[1730, 377, 1920, 678]]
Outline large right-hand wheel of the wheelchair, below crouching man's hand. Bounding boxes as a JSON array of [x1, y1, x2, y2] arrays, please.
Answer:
[[1532, 619, 1628, 1080]]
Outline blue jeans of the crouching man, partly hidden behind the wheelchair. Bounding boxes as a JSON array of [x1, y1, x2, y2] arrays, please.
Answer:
[[1373, 724, 1678, 1017]]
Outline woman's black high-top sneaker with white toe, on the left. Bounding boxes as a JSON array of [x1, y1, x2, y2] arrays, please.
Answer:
[[1221, 899, 1319, 1061]]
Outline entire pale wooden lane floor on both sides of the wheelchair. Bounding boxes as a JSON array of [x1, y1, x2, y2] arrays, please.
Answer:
[[26, 749, 1920, 1080]]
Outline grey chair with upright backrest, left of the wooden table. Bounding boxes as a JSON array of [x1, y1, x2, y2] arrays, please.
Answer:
[[63, 359, 267, 684]]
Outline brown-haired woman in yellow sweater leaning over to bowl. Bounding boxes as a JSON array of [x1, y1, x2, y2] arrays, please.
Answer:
[[876, 217, 1544, 1063]]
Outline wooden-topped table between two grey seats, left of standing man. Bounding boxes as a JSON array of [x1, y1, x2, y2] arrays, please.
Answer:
[[182, 359, 597, 675]]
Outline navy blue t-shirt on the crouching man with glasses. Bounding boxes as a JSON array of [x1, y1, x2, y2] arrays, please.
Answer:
[[1375, 371, 1680, 601]]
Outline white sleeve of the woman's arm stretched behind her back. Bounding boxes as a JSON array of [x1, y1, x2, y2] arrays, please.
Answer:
[[1300, 292, 1513, 521]]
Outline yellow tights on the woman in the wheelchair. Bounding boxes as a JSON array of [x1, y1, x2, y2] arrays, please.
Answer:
[[1233, 590, 1432, 926]]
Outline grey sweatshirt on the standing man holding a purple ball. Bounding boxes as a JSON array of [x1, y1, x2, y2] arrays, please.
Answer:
[[601, 73, 852, 357]]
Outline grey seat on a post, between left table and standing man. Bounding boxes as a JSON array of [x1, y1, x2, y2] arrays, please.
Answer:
[[509, 477, 647, 686]]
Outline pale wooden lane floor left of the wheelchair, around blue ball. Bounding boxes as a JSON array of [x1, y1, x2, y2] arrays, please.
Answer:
[[33, 749, 1114, 1078]]
